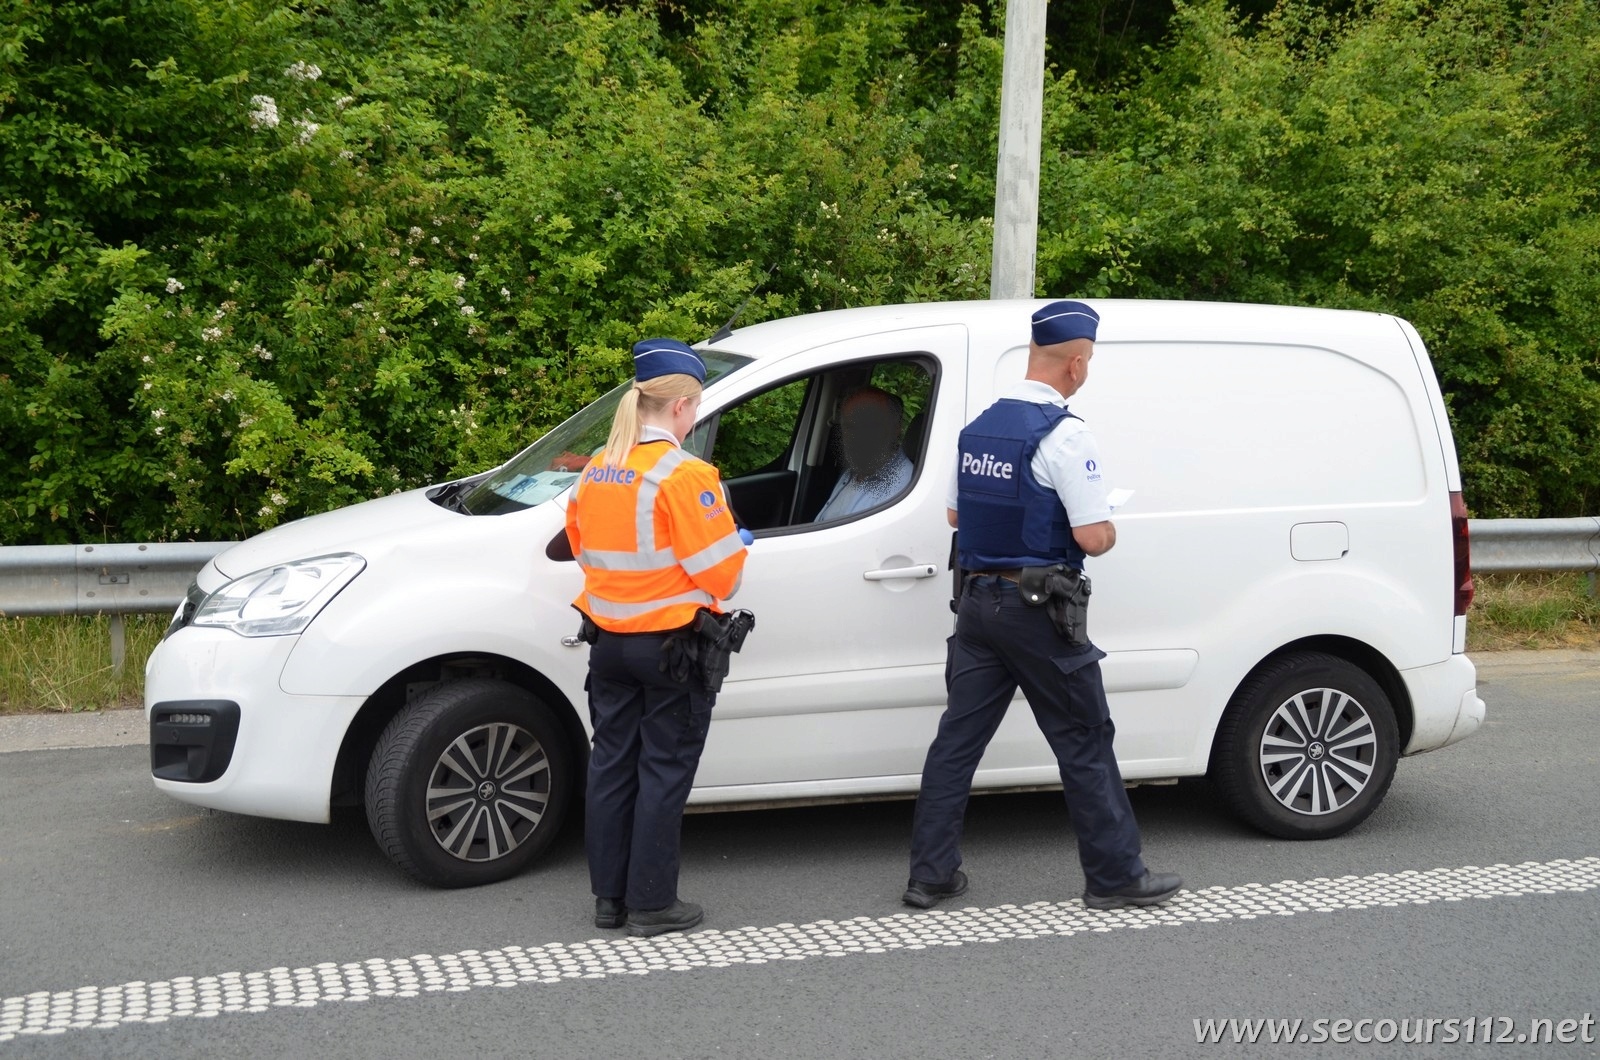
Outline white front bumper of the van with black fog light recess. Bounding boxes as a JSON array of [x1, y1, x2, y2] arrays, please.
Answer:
[[144, 626, 365, 823]]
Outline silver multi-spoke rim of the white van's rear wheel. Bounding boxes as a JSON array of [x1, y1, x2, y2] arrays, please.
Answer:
[[1259, 689, 1378, 817]]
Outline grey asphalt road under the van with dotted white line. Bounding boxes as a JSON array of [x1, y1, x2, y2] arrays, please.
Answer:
[[0, 655, 1600, 1060]]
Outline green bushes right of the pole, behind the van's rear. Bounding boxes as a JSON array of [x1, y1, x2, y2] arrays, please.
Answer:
[[1038, 0, 1600, 516]]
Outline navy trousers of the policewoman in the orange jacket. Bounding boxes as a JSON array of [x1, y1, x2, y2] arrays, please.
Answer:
[[584, 631, 717, 909]]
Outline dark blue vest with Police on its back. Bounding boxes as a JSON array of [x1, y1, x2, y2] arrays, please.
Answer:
[[957, 397, 1083, 570]]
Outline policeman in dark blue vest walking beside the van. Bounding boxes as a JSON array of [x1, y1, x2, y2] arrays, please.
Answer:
[[902, 301, 1182, 909]]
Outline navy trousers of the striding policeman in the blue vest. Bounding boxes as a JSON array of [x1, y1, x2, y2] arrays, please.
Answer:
[[910, 578, 1144, 893]]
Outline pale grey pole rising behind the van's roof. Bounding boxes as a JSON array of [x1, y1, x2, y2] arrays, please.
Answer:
[[989, 0, 1046, 298]]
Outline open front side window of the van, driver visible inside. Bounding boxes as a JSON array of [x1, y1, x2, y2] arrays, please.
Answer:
[[694, 355, 934, 532]]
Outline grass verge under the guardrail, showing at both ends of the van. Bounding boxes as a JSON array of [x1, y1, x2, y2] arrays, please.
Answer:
[[0, 575, 1600, 714]]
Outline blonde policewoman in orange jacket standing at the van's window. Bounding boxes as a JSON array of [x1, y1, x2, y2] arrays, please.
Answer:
[[566, 339, 746, 935]]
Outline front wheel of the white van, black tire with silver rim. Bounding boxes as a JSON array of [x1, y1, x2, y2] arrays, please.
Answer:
[[366, 679, 574, 887]]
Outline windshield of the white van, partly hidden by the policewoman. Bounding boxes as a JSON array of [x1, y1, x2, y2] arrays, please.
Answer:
[[451, 349, 750, 516]]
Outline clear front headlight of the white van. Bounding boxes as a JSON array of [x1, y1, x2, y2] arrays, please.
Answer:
[[190, 552, 366, 637]]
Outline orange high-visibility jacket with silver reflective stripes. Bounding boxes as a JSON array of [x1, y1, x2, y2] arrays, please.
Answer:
[[566, 440, 746, 632]]
